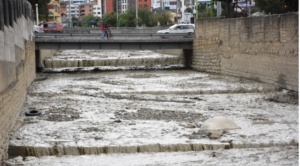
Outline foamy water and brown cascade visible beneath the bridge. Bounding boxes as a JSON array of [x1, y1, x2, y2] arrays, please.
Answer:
[[44, 51, 184, 68]]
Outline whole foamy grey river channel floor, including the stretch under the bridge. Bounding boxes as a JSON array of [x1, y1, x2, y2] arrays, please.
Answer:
[[6, 50, 299, 166]]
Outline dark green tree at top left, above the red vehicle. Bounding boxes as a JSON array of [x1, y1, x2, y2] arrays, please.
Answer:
[[28, 0, 50, 21]]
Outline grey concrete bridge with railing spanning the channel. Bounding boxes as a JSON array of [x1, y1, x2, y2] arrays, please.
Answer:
[[35, 33, 194, 50]]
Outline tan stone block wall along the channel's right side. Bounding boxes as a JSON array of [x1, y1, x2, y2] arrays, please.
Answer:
[[192, 13, 299, 92]]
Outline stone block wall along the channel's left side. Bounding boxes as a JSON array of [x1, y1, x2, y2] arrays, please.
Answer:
[[0, 0, 35, 162]]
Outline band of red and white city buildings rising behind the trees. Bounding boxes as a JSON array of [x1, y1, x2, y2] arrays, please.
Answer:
[[36, 0, 196, 23]]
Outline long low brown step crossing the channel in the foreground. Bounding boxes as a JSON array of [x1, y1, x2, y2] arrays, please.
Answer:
[[8, 142, 298, 157]]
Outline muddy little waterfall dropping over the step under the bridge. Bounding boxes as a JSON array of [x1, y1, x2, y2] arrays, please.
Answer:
[[44, 52, 184, 68]]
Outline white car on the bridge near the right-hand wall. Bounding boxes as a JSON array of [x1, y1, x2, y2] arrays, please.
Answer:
[[156, 24, 195, 37]]
